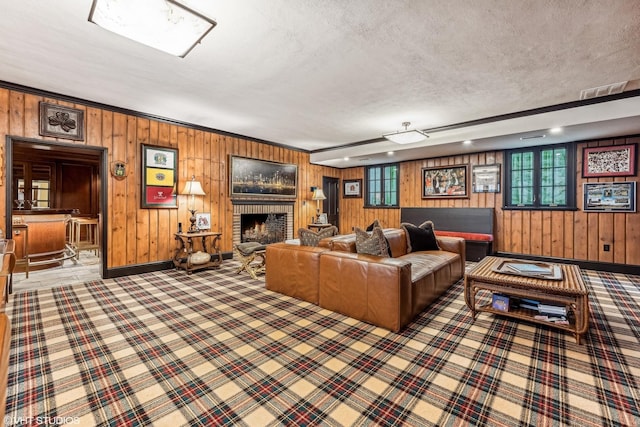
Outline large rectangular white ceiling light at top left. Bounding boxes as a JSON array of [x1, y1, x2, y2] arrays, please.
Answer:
[[89, 0, 216, 58]]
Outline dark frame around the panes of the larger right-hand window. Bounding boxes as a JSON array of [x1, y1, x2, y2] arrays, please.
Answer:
[[502, 143, 577, 211]]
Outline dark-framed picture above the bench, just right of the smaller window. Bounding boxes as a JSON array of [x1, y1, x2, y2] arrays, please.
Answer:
[[421, 165, 469, 199]]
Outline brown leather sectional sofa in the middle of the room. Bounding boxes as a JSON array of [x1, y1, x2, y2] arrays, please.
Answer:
[[266, 228, 465, 332]]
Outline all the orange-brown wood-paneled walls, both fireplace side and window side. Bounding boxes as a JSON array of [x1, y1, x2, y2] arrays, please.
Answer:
[[0, 89, 640, 268]]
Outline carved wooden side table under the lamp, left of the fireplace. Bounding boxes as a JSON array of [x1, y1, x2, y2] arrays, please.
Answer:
[[173, 231, 222, 274]]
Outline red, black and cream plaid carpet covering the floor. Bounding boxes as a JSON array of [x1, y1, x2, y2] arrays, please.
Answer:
[[5, 261, 640, 426]]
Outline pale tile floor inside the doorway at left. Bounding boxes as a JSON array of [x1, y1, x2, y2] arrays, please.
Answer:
[[13, 252, 100, 293]]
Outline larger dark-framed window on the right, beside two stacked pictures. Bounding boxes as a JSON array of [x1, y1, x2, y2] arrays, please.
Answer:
[[504, 144, 576, 210]]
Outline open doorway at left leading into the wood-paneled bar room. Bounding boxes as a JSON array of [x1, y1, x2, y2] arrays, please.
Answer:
[[5, 136, 108, 280]]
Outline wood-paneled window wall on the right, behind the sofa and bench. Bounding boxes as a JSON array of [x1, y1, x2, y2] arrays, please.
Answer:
[[341, 141, 640, 265]]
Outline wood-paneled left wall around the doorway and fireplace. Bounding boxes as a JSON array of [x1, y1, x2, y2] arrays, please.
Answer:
[[0, 88, 340, 268]]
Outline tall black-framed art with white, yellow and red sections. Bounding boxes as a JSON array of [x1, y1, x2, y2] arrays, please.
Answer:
[[140, 144, 178, 209]]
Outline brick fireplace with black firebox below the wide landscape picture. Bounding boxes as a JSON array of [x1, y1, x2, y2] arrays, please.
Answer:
[[233, 202, 293, 245]]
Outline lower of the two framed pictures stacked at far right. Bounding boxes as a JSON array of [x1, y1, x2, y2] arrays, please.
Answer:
[[582, 181, 636, 212]]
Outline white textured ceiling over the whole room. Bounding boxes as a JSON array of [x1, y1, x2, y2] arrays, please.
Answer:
[[0, 0, 640, 166]]
